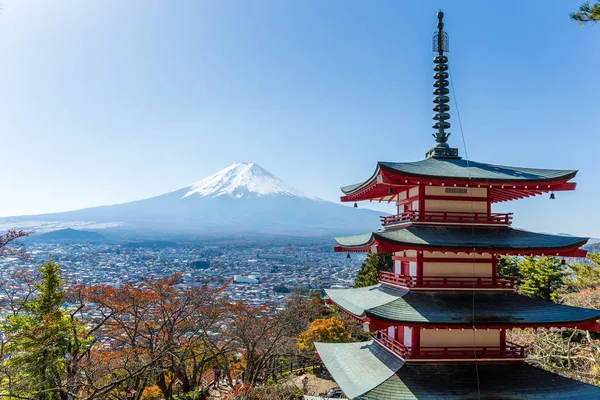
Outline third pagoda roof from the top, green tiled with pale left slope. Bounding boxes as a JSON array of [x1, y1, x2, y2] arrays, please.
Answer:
[[326, 285, 600, 327]]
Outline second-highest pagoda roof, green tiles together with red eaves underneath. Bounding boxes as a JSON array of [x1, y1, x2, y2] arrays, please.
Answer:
[[335, 225, 588, 256]]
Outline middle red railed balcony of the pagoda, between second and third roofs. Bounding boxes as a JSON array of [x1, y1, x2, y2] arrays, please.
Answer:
[[378, 271, 519, 290]]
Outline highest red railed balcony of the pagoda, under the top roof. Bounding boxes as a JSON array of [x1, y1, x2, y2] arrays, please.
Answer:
[[380, 211, 512, 227]]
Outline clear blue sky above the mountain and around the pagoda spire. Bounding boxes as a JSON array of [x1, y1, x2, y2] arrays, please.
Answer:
[[0, 0, 600, 237]]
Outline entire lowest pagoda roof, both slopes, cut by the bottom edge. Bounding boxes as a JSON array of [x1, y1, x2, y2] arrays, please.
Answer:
[[315, 341, 600, 400]]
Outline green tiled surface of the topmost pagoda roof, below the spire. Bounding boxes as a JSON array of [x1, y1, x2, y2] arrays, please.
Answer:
[[342, 158, 577, 194]]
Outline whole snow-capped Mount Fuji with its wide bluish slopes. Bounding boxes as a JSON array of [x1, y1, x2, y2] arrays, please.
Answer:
[[0, 163, 380, 237]]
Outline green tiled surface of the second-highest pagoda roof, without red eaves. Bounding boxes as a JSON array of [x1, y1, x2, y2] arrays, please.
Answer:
[[335, 225, 588, 250]]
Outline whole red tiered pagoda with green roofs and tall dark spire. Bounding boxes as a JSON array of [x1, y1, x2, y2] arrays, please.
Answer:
[[316, 12, 600, 400]]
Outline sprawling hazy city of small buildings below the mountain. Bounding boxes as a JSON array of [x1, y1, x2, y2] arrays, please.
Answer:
[[0, 238, 364, 305]]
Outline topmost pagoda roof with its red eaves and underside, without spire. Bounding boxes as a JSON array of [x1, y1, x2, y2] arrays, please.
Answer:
[[341, 157, 577, 203]]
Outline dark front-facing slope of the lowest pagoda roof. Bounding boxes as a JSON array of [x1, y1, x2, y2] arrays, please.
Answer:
[[358, 363, 600, 400]]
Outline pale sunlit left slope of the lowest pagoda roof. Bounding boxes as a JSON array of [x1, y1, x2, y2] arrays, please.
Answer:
[[315, 341, 404, 398]]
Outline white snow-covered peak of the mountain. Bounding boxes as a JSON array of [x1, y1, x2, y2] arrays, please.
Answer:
[[182, 162, 312, 198]]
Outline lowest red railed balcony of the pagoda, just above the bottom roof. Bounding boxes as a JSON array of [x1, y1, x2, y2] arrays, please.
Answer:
[[374, 331, 527, 362]]
